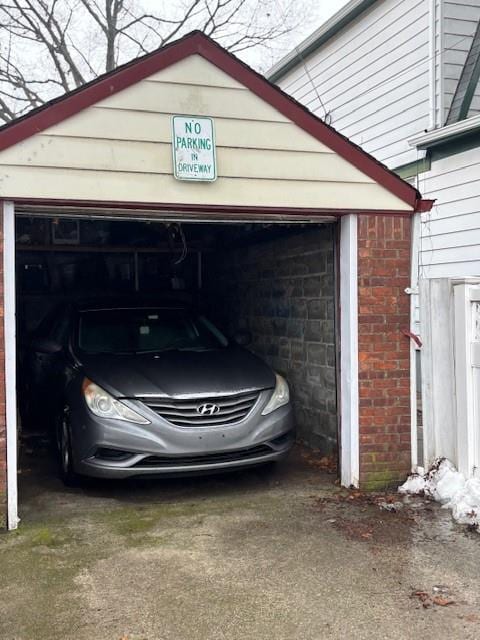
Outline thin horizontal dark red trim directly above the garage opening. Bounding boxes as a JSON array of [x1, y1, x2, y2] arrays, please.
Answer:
[[8, 198, 411, 218]]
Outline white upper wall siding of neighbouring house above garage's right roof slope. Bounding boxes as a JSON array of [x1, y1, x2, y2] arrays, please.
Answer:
[[279, 0, 431, 168]]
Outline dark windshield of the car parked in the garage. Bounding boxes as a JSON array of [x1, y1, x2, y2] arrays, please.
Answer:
[[78, 308, 228, 354]]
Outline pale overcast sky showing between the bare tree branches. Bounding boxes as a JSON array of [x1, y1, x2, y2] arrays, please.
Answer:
[[0, 0, 348, 124]]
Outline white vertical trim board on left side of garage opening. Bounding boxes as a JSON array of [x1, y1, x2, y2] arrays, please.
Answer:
[[3, 202, 18, 530]]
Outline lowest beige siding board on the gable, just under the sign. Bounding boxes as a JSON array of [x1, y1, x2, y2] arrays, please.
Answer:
[[3, 165, 408, 211]]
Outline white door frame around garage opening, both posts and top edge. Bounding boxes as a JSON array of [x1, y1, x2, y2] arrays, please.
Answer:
[[3, 201, 359, 530]]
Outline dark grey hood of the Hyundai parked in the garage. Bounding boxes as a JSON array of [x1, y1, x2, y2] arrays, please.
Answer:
[[80, 347, 275, 398]]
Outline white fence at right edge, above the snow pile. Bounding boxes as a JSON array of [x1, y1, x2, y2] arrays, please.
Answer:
[[418, 278, 480, 477]]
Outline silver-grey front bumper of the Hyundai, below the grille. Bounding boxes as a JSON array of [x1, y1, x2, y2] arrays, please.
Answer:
[[71, 390, 295, 479]]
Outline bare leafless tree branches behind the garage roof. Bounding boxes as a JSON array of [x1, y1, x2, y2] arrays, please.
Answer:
[[0, 0, 312, 123]]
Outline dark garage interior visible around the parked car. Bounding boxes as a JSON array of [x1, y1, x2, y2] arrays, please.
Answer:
[[16, 213, 338, 490]]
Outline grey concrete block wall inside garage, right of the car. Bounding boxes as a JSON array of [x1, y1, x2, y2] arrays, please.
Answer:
[[205, 225, 337, 453]]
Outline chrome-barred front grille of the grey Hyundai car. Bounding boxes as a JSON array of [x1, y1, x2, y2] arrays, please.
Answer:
[[138, 391, 259, 427]]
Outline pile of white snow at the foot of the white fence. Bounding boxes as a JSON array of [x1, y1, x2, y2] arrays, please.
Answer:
[[398, 458, 480, 532]]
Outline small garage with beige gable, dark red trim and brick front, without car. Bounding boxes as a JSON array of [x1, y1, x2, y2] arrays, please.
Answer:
[[0, 33, 431, 529]]
